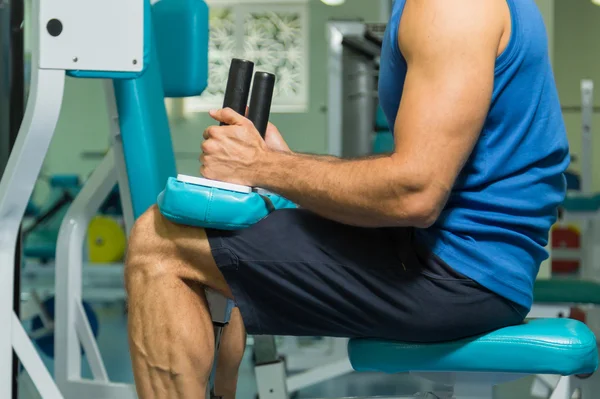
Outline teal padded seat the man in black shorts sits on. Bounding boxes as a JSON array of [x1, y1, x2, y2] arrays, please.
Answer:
[[348, 319, 598, 376]]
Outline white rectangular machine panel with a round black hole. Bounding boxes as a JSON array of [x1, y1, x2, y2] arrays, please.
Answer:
[[34, 0, 144, 72]]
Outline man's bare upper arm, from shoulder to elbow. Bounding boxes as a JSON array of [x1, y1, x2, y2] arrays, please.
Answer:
[[394, 0, 501, 198]]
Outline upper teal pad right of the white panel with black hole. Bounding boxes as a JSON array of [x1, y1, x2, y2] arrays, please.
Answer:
[[152, 0, 209, 97]]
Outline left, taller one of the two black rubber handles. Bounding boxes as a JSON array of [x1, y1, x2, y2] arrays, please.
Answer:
[[221, 58, 254, 126]]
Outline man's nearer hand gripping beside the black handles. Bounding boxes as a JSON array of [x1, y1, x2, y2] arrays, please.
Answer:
[[200, 108, 268, 186]]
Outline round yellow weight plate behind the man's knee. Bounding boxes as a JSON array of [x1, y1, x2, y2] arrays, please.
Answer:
[[88, 216, 127, 263]]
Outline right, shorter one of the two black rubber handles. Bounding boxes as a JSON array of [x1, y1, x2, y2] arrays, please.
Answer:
[[248, 72, 275, 138]]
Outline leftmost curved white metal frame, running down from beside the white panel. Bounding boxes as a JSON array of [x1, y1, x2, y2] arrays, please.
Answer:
[[0, 1, 65, 399]]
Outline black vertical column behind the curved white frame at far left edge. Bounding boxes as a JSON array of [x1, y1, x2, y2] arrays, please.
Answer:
[[0, 0, 25, 399]]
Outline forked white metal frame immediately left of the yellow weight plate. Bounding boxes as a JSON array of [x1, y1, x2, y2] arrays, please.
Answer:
[[55, 81, 137, 399]]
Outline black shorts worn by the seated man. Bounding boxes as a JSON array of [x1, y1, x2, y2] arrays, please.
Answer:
[[207, 209, 526, 342]]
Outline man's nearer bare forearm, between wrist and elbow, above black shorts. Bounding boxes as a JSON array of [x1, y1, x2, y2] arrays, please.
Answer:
[[257, 153, 424, 227]]
